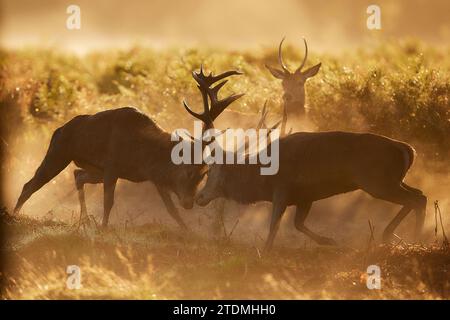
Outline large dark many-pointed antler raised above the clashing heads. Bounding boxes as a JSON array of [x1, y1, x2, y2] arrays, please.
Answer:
[[183, 65, 244, 128]]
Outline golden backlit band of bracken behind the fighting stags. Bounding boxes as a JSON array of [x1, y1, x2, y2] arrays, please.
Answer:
[[0, 40, 450, 161]]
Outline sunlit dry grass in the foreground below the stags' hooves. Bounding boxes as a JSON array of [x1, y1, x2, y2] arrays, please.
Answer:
[[2, 212, 450, 299]]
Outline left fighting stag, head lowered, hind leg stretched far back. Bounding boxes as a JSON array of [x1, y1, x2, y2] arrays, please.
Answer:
[[14, 107, 205, 229]]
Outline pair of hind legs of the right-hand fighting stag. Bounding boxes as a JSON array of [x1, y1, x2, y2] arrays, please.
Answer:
[[364, 182, 427, 242]]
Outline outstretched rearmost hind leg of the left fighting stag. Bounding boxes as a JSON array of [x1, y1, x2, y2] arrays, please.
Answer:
[[14, 130, 71, 214]]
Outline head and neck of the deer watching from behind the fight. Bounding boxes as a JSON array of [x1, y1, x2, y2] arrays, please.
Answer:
[[266, 38, 322, 119]]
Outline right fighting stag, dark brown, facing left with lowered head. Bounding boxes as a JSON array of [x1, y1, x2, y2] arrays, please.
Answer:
[[185, 72, 427, 251]]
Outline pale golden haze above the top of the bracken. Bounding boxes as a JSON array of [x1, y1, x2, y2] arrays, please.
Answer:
[[0, 0, 450, 53]]
